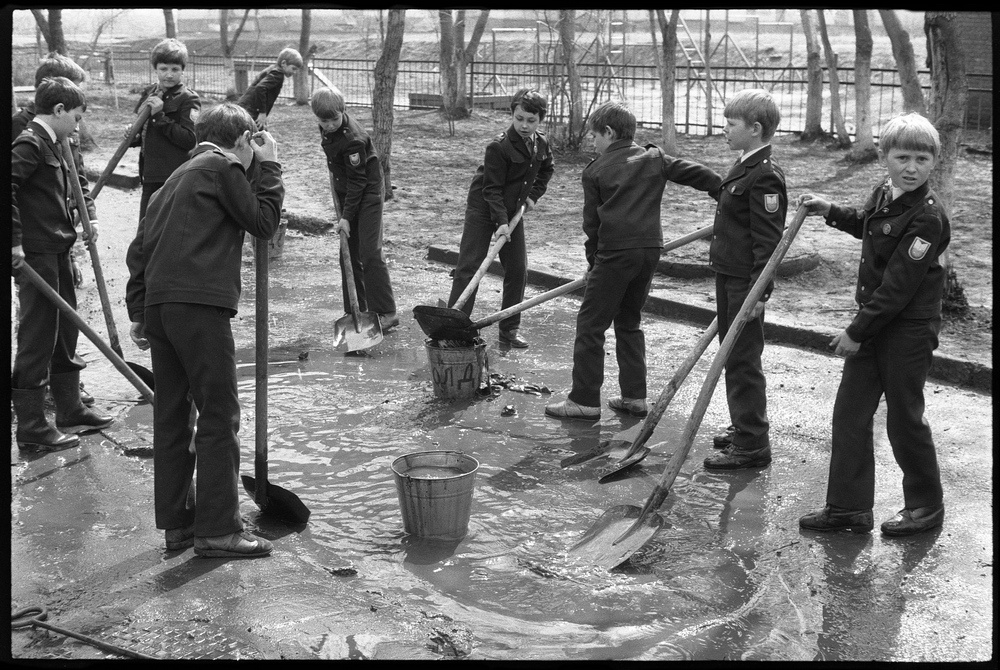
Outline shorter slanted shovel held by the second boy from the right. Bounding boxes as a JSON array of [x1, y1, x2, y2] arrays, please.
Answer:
[[559, 319, 719, 482]]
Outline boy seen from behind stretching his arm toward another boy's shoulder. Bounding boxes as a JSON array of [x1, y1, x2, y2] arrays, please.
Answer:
[[545, 102, 721, 421]]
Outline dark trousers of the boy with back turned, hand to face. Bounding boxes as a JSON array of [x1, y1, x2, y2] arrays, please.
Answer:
[[145, 303, 243, 537]]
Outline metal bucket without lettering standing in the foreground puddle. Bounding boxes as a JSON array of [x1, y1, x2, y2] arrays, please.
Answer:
[[392, 451, 479, 541]]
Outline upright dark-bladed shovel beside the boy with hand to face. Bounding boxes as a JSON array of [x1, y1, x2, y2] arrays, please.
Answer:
[[241, 237, 309, 524]]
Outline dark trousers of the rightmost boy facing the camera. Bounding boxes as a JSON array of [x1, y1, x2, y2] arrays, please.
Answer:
[[826, 317, 943, 509]]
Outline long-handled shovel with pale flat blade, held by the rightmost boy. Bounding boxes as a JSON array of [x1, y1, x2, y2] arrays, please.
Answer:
[[569, 207, 807, 569]]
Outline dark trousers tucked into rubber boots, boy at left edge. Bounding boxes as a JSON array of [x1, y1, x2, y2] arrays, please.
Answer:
[[10, 251, 87, 389]]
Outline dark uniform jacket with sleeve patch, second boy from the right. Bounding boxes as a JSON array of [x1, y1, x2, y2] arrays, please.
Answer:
[[708, 145, 788, 300]]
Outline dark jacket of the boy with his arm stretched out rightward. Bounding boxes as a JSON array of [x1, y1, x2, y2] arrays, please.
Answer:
[[582, 139, 722, 267]]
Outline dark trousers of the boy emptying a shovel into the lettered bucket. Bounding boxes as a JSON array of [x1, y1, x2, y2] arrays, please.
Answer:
[[448, 211, 528, 331]]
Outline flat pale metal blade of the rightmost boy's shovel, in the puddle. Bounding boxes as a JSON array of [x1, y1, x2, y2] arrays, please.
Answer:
[[569, 505, 663, 570]]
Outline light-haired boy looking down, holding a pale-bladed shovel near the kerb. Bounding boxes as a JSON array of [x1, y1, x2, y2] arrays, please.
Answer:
[[310, 88, 399, 332]]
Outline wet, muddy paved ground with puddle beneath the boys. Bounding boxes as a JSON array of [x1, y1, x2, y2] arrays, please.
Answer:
[[11, 188, 993, 661]]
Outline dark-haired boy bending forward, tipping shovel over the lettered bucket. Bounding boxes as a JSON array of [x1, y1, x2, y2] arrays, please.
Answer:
[[448, 88, 554, 349]]
